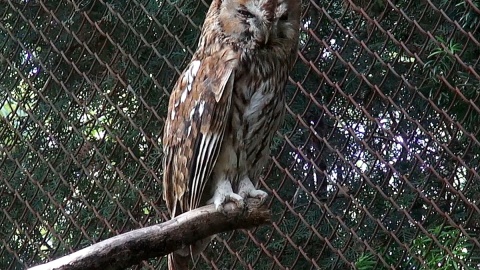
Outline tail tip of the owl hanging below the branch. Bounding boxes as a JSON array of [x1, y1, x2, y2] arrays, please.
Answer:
[[168, 236, 214, 270]]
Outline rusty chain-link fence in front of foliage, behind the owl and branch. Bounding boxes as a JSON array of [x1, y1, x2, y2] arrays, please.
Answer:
[[0, 0, 480, 269]]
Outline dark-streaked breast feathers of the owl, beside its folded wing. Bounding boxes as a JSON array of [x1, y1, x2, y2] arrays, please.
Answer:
[[230, 51, 289, 178]]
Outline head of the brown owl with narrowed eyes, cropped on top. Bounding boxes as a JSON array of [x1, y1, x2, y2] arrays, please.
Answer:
[[217, 0, 301, 49]]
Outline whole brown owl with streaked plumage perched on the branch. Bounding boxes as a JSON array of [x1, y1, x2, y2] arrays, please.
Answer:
[[163, 0, 301, 269]]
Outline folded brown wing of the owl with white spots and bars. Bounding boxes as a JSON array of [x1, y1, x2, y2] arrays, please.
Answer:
[[163, 49, 238, 217]]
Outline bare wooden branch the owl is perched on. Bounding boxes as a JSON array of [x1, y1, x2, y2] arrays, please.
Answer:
[[29, 199, 270, 270]]
